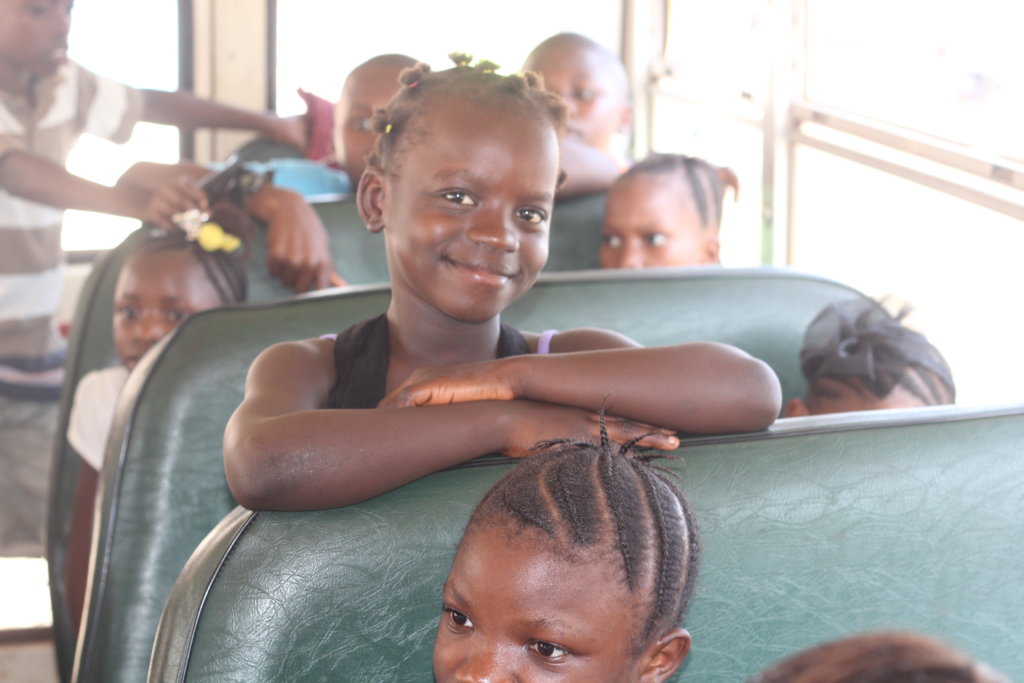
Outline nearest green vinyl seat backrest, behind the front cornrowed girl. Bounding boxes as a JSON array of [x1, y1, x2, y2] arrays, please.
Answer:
[[150, 405, 1024, 683]]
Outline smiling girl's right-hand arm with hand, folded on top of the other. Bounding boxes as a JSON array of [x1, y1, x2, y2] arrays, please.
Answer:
[[381, 330, 781, 434]]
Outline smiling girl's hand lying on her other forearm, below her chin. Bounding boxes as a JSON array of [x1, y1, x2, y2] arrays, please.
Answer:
[[377, 361, 519, 408]]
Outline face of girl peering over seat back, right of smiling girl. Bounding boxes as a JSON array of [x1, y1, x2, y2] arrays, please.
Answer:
[[601, 173, 719, 268]]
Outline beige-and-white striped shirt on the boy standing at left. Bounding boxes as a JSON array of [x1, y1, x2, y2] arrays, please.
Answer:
[[0, 62, 142, 398]]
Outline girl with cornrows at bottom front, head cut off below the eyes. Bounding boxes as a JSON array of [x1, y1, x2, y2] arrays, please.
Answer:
[[434, 435, 700, 683]]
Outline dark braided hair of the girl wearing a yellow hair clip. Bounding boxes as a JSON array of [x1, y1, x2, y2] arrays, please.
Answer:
[[132, 200, 257, 304]]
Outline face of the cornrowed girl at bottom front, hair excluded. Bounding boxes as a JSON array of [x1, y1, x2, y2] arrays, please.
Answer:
[[434, 525, 655, 683]]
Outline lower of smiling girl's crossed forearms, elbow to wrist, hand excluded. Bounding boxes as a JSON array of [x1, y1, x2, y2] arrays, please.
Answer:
[[224, 401, 515, 510]]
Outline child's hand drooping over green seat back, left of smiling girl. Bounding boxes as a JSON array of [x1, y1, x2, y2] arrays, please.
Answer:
[[246, 185, 346, 293]]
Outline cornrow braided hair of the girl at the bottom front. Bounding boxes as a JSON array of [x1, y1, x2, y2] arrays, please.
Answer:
[[463, 430, 700, 652]]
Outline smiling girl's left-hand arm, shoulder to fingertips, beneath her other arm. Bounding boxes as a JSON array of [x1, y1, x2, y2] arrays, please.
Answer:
[[224, 340, 678, 510]]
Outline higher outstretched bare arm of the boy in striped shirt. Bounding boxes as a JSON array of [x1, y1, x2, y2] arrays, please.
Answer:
[[142, 90, 306, 152]]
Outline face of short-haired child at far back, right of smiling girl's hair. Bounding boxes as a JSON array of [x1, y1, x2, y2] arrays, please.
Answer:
[[523, 42, 631, 152]]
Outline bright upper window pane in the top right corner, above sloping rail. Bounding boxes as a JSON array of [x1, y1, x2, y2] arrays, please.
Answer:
[[805, 0, 1024, 160]]
